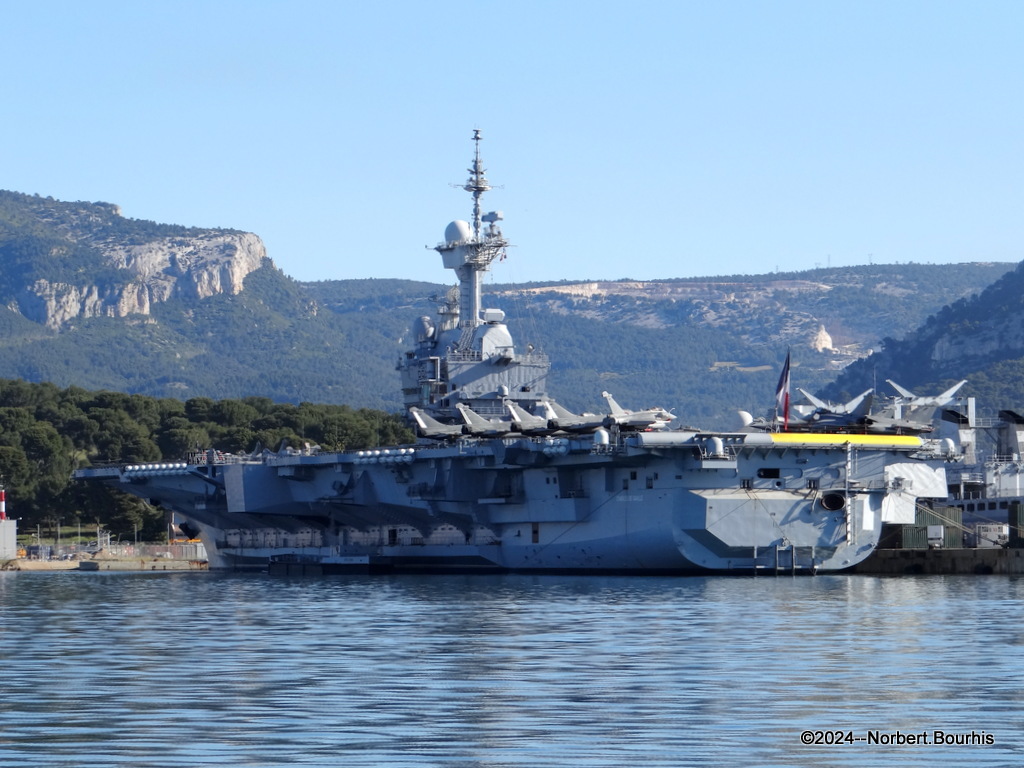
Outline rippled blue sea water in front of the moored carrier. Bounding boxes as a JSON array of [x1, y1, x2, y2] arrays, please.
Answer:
[[0, 572, 1024, 768]]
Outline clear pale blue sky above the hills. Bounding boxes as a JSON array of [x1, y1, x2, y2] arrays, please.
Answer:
[[0, 0, 1024, 283]]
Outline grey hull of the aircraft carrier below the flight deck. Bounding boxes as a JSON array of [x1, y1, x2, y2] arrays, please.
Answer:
[[78, 431, 946, 573]]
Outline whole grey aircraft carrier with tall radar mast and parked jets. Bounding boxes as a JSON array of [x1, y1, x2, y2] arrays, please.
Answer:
[[76, 131, 956, 572]]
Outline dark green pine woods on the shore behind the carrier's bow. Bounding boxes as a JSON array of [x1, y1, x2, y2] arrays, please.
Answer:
[[0, 379, 414, 538]]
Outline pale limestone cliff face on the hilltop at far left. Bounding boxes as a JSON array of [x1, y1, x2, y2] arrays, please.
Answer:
[[17, 231, 267, 330]]
